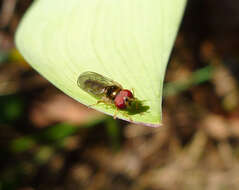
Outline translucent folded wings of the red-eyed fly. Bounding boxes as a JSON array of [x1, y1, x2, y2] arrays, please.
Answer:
[[77, 71, 122, 98]]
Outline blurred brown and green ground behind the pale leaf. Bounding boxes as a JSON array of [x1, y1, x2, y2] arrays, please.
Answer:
[[0, 0, 239, 190]]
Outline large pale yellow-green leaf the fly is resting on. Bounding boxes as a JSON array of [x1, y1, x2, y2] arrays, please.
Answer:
[[16, 0, 186, 127]]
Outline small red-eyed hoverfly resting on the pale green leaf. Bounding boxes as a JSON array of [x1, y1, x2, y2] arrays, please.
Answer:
[[77, 71, 137, 113]]
